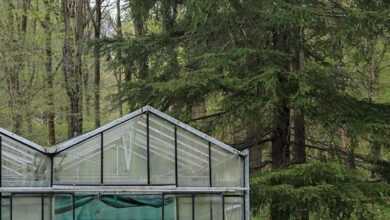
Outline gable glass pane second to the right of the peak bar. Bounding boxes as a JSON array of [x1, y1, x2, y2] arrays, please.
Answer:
[[177, 128, 210, 186]]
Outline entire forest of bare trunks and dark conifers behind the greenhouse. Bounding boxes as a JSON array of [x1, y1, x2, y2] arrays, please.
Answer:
[[0, 0, 390, 220]]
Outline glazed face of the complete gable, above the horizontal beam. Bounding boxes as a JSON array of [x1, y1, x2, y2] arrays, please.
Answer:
[[50, 113, 244, 187]]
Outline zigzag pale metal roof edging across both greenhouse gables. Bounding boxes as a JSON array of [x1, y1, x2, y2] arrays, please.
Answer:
[[0, 106, 245, 155]]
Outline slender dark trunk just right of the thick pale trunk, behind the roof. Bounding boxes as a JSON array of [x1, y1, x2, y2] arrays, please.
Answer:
[[94, 0, 102, 128]]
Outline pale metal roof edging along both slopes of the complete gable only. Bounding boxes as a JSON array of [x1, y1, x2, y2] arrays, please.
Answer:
[[50, 106, 245, 155]]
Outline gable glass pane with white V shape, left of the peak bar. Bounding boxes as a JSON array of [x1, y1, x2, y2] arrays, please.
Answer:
[[103, 115, 148, 184]]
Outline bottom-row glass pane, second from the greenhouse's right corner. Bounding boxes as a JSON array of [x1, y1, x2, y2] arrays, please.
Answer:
[[195, 196, 222, 220]]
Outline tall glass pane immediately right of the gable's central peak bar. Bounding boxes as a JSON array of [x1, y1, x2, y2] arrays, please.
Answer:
[[149, 114, 175, 184]]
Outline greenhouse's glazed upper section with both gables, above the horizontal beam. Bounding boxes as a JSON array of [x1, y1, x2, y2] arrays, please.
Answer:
[[0, 106, 248, 192]]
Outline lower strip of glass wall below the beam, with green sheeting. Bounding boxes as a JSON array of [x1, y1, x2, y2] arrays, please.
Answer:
[[1, 194, 244, 220]]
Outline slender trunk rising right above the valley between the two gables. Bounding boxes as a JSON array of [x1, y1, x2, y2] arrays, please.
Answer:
[[43, 0, 56, 145]]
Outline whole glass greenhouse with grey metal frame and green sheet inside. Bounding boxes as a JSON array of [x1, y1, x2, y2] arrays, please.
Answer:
[[0, 106, 250, 220]]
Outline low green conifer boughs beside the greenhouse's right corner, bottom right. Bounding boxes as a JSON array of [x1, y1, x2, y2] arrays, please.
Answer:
[[251, 162, 390, 219]]
